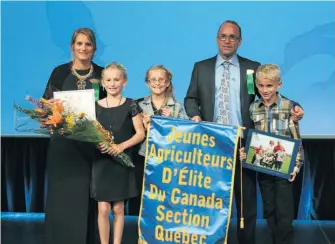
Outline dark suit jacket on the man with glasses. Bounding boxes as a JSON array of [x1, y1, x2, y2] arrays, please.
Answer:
[[184, 55, 260, 128]]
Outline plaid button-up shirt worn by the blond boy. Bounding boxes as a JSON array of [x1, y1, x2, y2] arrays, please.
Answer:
[[249, 93, 304, 172]]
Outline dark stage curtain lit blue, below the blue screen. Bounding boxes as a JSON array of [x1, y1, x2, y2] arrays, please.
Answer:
[[1, 137, 335, 220]]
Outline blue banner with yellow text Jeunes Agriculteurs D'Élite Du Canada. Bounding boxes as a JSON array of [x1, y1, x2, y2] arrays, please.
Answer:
[[139, 116, 239, 244]]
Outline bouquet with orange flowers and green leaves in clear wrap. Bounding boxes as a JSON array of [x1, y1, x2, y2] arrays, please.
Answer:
[[14, 96, 135, 167]]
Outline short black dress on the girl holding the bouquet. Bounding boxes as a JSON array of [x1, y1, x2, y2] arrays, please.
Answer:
[[91, 98, 141, 202]]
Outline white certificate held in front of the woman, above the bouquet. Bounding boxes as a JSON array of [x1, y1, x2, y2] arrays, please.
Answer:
[[54, 89, 96, 120]]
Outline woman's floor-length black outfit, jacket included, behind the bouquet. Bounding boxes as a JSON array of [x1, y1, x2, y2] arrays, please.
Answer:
[[44, 64, 105, 244]]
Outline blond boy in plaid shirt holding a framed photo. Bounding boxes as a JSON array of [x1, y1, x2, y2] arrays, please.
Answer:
[[240, 64, 304, 244]]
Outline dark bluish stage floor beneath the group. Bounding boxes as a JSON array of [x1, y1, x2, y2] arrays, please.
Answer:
[[1, 213, 335, 244]]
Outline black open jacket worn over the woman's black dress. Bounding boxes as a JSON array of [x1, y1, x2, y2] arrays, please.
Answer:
[[43, 62, 107, 99]]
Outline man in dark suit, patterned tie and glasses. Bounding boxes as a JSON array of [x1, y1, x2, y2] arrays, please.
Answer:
[[184, 20, 303, 244]]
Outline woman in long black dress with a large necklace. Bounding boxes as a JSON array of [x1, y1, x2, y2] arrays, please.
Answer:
[[43, 28, 106, 244]]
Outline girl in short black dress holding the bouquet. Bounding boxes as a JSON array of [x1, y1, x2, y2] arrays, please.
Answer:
[[91, 63, 144, 244]]
